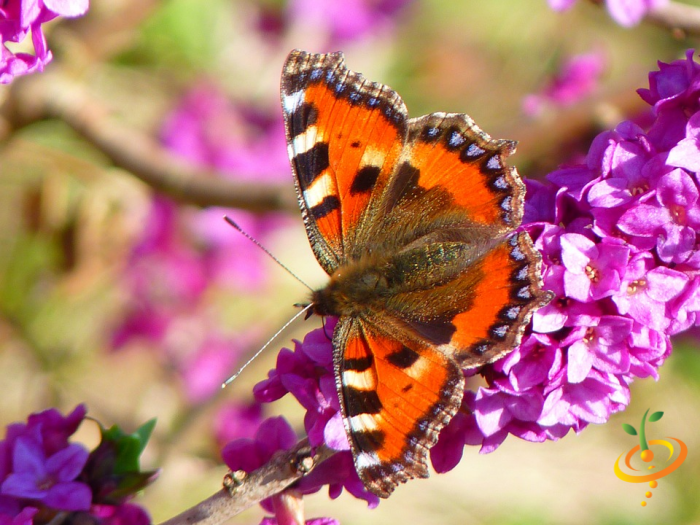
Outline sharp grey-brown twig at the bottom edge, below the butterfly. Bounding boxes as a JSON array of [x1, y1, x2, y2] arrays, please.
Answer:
[[161, 439, 335, 525]]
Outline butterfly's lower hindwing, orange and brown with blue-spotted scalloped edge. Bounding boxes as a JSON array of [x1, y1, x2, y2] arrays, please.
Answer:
[[386, 233, 549, 368]]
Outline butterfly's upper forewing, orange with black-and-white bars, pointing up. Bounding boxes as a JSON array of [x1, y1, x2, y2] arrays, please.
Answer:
[[282, 51, 407, 273]]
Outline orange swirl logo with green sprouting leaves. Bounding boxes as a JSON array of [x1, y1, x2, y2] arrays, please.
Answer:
[[615, 409, 688, 507]]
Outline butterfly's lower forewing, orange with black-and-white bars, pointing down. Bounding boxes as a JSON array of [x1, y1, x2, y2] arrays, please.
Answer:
[[333, 317, 464, 497]]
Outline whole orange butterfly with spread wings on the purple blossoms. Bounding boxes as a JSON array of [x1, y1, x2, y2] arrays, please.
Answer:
[[281, 50, 549, 498]]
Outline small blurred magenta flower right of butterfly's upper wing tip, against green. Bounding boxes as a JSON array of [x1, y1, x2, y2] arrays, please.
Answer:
[[523, 52, 605, 116]]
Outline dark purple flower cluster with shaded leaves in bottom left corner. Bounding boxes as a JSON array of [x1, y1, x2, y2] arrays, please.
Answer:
[[0, 405, 154, 525]]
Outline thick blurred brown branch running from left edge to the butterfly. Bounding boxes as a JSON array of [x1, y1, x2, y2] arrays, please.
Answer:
[[3, 68, 298, 213]]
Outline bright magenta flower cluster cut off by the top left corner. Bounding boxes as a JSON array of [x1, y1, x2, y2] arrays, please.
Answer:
[[0, 0, 89, 84]]
